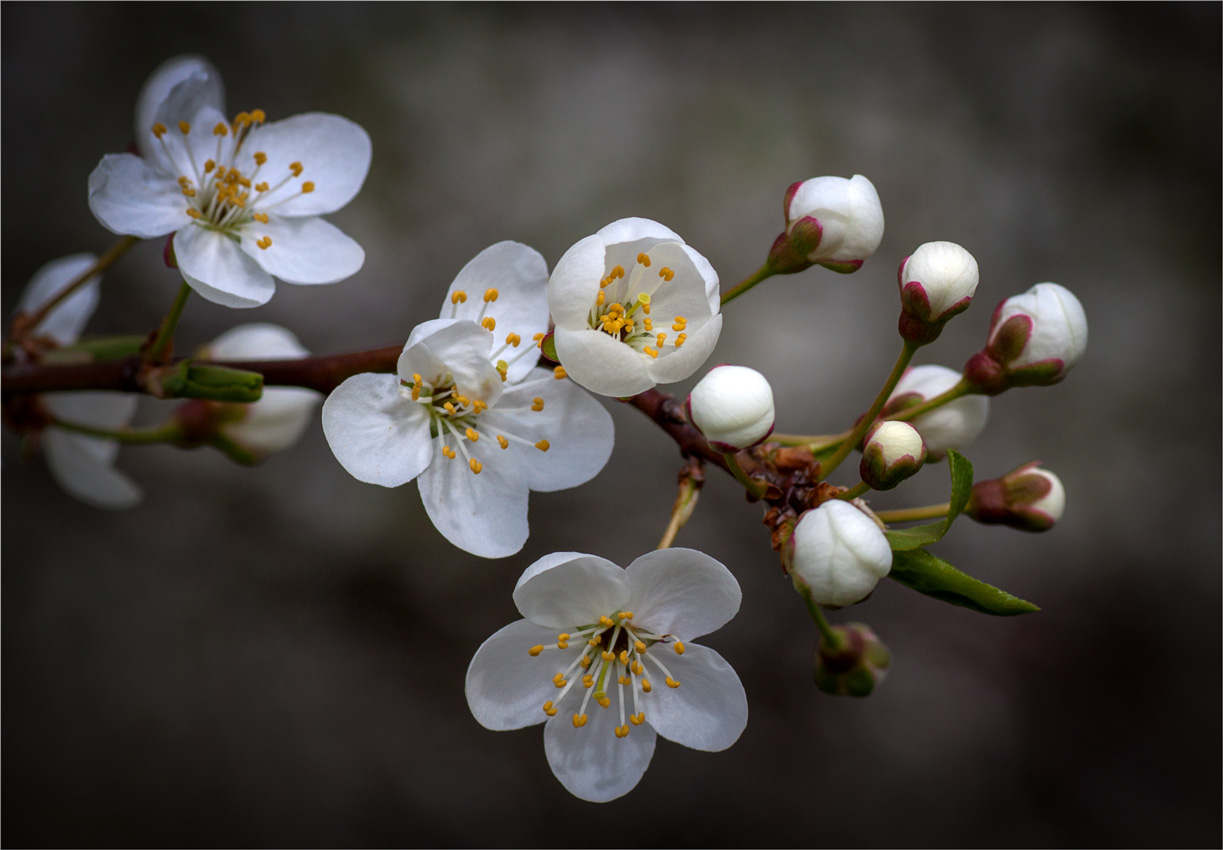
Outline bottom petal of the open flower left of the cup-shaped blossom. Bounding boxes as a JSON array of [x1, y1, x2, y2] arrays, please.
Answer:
[[417, 440, 530, 558]]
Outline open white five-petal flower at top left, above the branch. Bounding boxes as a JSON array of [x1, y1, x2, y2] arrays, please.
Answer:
[[89, 56, 371, 307]]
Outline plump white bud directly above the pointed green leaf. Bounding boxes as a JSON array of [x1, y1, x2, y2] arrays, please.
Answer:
[[786, 499, 892, 608]]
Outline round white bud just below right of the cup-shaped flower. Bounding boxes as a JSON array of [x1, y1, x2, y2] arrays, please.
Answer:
[[685, 366, 773, 451]]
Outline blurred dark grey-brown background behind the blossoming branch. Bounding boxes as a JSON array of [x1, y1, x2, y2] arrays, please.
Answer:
[[0, 4, 1221, 846]]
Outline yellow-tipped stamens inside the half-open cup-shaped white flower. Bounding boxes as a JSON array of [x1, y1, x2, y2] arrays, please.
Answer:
[[588, 242, 687, 358]]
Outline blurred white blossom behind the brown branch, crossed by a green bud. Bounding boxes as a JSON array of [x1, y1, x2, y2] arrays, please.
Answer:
[[199, 323, 322, 454]]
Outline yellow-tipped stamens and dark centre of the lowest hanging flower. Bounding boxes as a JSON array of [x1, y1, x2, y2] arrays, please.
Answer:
[[527, 612, 684, 737]]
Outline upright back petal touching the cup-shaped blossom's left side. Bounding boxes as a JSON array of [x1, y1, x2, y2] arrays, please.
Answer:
[[442, 242, 548, 383]]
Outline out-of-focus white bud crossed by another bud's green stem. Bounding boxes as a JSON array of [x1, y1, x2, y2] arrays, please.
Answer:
[[883, 366, 989, 460]]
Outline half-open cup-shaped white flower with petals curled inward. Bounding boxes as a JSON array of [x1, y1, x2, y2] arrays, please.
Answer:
[[548, 219, 722, 397]]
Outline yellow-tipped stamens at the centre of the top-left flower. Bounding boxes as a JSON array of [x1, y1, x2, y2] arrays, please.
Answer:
[[153, 109, 316, 249]]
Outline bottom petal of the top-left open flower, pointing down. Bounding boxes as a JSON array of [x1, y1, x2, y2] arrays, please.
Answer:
[[174, 226, 276, 307]]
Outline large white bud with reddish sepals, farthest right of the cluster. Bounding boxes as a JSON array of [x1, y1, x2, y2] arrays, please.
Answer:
[[964, 284, 1087, 395]]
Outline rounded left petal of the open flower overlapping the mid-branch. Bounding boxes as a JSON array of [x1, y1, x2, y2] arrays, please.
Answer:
[[323, 372, 433, 487]]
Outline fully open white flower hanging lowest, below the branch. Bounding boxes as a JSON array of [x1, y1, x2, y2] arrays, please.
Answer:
[[466, 549, 747, 802]]
